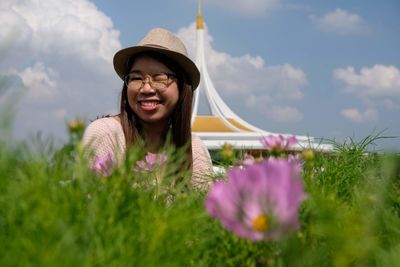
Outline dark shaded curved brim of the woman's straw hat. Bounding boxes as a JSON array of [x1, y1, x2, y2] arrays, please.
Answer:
[[113, 46, 200, 90]]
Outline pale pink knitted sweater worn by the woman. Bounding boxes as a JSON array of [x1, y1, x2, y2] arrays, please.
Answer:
[[83, 117, 213, 189]]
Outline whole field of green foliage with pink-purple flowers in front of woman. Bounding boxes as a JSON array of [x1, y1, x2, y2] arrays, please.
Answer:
[[0, 121, 400, 266]]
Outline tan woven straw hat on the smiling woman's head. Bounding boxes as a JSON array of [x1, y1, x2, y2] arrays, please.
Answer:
[[114, 28, 200, 90]]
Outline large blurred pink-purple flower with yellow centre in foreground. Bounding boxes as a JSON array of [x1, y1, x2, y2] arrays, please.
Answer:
[[205, 158, 305, 241]]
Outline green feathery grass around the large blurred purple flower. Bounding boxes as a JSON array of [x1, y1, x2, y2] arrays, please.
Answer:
[[0, 133, 400, 266]]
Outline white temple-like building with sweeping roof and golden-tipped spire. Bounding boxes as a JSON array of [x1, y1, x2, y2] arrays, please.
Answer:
[[192, 0, 332, 150]]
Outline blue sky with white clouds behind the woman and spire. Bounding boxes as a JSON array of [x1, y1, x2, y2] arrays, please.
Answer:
[[0, 0, 400, 150]]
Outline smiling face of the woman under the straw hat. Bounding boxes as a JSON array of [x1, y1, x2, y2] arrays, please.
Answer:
[[128, 55, 179, 125]]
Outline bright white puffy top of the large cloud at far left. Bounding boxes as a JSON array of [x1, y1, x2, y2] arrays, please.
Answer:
[[2, 0, 120, 62]]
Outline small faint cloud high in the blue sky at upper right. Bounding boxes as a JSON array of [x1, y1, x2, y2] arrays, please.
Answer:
[[309, 8, 368, 34]]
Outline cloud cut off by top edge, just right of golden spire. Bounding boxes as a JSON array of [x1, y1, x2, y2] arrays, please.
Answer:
[[206, 0, 281, 16]]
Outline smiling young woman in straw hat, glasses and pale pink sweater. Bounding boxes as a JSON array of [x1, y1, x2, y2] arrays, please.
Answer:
[[83, 28, 212, 191]]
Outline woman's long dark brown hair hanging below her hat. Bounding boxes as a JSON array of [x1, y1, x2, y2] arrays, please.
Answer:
[[120, 52, 193, 169]]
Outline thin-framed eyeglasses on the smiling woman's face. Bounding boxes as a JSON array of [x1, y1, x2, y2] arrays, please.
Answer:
[[124, 72, 177, 91]]
